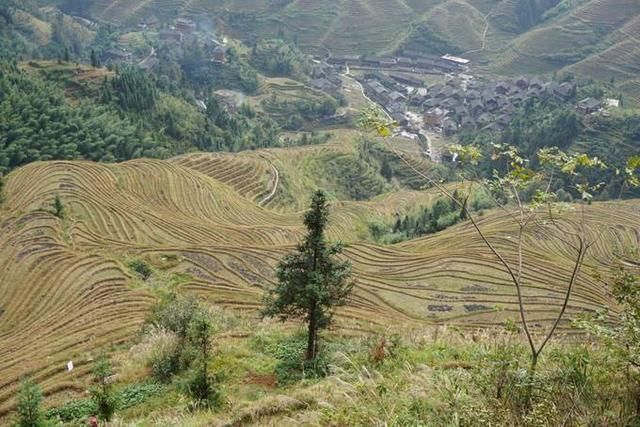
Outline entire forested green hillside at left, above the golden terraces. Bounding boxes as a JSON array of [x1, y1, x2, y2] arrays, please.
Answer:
[[0, 61, 290, 171]]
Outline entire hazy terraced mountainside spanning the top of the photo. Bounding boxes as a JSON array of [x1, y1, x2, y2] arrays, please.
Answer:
[[62, 0, 640, 102]]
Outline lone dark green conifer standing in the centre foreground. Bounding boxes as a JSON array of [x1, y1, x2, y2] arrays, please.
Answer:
[[263, 190, 353, 360]]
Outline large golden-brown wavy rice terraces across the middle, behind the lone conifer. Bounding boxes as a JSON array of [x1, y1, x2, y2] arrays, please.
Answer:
[[0, 147, 640, 417]]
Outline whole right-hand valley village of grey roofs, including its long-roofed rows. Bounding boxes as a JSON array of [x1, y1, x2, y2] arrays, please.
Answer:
[[312, 50, 619, 160]]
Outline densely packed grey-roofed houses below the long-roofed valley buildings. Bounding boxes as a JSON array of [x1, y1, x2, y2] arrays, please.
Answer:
[[361, 70, 619, 140]]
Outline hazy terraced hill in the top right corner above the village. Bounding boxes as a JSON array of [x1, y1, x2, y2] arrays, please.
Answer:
[[491, 0, 640, 101]]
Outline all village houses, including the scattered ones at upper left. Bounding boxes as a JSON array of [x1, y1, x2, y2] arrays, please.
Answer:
[[70, 13, 619, 160]]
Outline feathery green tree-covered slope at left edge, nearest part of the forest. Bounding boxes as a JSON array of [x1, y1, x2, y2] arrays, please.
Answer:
[[0, 61, 172, 172]]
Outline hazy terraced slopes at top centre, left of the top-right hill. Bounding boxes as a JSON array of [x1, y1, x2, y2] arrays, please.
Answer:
[[80, 0, 514, 54]]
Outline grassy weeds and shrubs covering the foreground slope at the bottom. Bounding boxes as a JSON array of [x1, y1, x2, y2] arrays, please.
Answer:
[[23, 309, 638, 427]]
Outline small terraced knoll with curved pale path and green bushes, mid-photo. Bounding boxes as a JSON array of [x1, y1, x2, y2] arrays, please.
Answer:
[[169, 129, 444, 212]]
